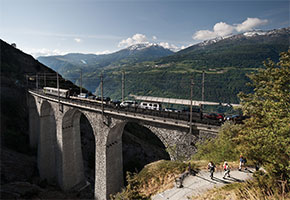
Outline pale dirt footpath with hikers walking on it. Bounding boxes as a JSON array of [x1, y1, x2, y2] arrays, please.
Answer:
[[151, 169, 254, 200]]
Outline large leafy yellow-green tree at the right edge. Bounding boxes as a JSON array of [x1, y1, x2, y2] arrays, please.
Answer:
[[238, 50, 290, 184]]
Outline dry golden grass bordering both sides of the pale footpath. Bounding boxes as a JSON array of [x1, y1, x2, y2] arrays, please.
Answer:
[[111, 160, 290, 200]]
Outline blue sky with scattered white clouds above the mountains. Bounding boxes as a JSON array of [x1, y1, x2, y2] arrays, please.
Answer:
[[0, 0, 289, 57]]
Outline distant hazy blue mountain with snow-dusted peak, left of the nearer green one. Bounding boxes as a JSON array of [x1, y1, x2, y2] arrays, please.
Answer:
[[37, 44, 173, 81]]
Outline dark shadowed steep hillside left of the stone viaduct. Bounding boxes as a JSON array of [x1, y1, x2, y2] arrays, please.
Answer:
[[0, 40, 82, 199]]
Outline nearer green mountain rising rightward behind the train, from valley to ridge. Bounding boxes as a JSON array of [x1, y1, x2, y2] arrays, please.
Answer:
[[86, 28, 290, 103]]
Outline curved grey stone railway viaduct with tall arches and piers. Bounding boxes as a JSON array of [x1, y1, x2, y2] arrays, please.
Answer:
[[28, 90, 219, 200]]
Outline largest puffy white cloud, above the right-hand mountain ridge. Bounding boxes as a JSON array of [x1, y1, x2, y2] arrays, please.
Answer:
[[192, 18, 268, 40]]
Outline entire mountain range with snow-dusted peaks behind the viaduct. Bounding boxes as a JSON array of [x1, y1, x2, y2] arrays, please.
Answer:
[[38, 27, 290, 103]]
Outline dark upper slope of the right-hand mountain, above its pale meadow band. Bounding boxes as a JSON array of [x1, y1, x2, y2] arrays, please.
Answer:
[[157, 28, 290, 68]]
